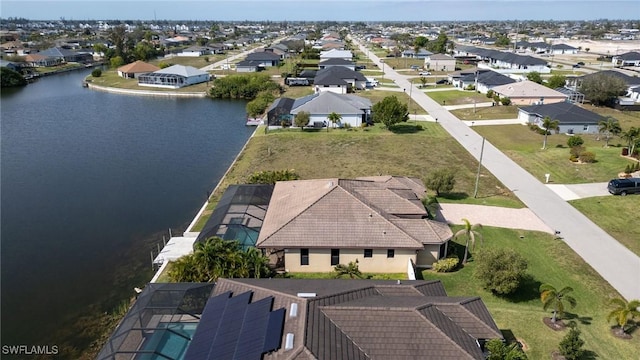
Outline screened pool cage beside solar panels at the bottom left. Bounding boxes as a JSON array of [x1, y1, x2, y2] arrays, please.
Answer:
[[96, 283, 214, 360]]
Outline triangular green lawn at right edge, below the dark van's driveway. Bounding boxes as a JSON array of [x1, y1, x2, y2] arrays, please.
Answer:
[[570, 195, 640, 256]]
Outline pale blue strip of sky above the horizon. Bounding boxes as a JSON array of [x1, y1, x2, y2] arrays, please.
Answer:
[[0, 0, 640, 21]]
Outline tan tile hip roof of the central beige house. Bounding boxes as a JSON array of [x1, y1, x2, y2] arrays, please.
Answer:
[[256, 177, 452, 249]]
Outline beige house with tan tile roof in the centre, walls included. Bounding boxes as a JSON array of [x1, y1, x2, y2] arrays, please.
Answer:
[[256, 176, 453, 273]]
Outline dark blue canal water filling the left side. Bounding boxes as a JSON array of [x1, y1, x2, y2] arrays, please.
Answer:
[[0, 70, 253, 354]]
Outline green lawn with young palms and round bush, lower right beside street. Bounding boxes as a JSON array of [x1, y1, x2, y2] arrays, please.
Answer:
[[422, 227, 640, 359]]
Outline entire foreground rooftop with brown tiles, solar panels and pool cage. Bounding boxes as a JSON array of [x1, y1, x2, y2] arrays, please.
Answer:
[[97, 279, 503, 360]]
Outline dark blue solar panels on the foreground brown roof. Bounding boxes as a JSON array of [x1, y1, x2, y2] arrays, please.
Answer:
[[184, 291, 285, 360]]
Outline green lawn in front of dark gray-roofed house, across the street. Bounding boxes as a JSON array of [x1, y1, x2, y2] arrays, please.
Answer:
[[474, 125, 632, 184]]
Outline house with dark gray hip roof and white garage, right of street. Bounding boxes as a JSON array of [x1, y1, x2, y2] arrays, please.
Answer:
[[518, 102, 604, 134]]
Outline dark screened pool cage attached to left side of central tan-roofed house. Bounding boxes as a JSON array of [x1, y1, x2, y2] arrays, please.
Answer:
[[196, 184, 274, 250]]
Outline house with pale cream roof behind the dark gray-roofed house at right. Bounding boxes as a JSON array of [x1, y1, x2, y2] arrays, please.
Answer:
[[492, 80, 567, 105]]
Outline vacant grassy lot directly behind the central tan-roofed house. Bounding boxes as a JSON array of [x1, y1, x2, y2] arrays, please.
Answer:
[[193, 123, 521, 231]]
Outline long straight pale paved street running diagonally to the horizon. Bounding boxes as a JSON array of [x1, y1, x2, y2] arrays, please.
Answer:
[[353, 39, 640, 299]]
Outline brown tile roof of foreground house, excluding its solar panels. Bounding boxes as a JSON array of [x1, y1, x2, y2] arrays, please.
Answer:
[[214, 279, 502, 360]]
